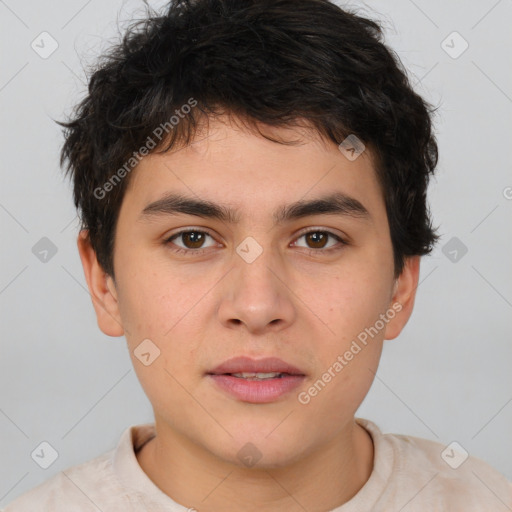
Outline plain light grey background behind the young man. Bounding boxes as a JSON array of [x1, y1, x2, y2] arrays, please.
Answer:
[[0, 0, 512, 506]]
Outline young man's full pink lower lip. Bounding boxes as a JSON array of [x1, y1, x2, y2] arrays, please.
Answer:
[[208, 374, 305, 404]]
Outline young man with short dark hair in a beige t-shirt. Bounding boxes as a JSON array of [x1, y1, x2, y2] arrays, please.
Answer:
[[5, 0, 512, 512]]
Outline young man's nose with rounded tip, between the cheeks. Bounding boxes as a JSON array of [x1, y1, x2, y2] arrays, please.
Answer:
[[218, 249, 296, 334]]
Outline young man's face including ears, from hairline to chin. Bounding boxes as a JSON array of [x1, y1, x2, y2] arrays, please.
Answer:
[[79, 115, 418, 467]]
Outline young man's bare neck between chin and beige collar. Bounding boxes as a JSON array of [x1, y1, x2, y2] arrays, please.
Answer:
[[137, 422, 374, 512]]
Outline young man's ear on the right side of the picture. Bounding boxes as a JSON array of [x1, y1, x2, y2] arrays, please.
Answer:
[[384, 256, 421, 340]]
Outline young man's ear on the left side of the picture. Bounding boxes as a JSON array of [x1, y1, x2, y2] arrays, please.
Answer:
[[77, 229, 124, 336]]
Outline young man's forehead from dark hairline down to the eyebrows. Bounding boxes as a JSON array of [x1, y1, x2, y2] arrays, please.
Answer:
[[120, 119, 383, 223]]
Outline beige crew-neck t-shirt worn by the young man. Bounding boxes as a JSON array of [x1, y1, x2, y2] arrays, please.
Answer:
[[4, 419, 512, 512]]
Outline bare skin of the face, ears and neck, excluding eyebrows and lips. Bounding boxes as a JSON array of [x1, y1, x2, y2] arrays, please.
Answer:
[[78, 118, 420, 512]]
